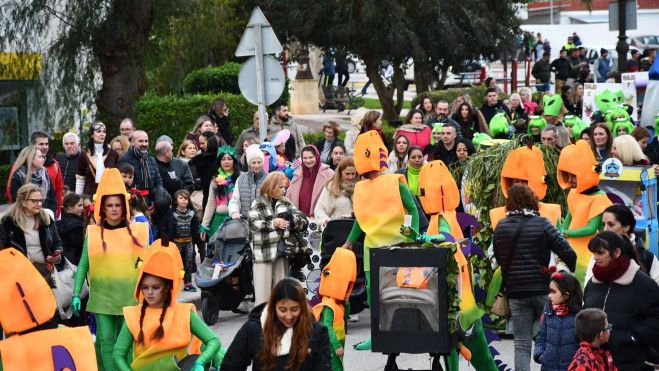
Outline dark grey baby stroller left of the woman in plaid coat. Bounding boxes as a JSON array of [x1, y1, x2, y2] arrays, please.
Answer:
[[195, 219, 254, 325]]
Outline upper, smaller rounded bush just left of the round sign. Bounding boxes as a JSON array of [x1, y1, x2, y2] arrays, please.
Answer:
[[183, 62, 240, 94]]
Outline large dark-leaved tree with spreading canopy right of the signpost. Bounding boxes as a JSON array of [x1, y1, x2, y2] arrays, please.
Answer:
[[262, 0, 518, 120]]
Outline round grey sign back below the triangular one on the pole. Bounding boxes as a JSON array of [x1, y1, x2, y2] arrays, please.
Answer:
[[238, 55, 286, 105]]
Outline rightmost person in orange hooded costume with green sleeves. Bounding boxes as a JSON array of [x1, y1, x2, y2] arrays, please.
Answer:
[[557, 140, 611, 286]]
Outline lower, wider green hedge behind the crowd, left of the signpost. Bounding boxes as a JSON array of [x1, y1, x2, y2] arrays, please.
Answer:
[[137, 93, 257, 152]]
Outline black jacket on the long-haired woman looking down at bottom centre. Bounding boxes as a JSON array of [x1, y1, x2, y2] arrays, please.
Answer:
[[221, 303, 331, 371]]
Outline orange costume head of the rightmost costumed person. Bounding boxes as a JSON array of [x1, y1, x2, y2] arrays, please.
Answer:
[[556, 140, 600, 193]]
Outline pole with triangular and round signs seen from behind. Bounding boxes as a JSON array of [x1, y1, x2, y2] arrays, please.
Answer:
[[236, 6, 285, 143]]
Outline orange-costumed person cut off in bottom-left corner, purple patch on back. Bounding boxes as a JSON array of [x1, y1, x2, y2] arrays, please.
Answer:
[[0, 248, 97, 371]]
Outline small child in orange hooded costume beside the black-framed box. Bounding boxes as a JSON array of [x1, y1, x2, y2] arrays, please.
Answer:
[[313, 248, 357, 371]]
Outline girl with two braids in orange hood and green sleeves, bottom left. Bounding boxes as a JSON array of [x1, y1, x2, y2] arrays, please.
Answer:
[[112, 240, 222, 371]]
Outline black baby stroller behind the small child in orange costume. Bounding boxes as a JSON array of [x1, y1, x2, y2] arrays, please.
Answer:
[[318, 219, 368, 314]]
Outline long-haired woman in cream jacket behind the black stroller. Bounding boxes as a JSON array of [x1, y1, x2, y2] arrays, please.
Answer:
[[314, 157, 357, 226]]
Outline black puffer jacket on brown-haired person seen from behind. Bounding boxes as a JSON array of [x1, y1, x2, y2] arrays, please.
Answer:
[[493, 215, 577, 298]]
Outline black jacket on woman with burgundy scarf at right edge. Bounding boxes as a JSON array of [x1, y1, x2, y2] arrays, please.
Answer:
[[584, 263, 659, 371]]
